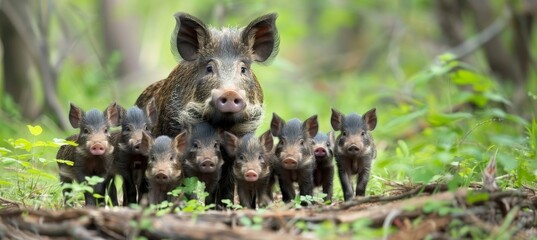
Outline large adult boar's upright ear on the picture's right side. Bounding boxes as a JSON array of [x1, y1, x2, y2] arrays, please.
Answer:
[[242, 13, 280, 62]]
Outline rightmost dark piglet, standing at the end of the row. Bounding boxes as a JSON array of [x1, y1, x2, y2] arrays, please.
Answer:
[[330, 108, 377, 201]]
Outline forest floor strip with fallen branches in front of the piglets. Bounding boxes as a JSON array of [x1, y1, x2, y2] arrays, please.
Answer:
[[0, 184, 537, 239]]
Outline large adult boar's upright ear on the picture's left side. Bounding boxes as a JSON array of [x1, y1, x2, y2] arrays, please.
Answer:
[[171, 12, 210, 61]]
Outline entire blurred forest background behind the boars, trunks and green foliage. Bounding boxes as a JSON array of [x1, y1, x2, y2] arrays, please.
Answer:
[[0, 0, 537, 206]]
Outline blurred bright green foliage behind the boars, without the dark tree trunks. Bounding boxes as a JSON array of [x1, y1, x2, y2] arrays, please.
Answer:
[[0, 0, 537, 208]]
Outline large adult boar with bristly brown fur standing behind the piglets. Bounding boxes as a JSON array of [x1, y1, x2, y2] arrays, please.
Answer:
[[136, 13, 279, 136]]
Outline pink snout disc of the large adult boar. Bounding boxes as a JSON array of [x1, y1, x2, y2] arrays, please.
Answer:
[[212, 90, 246, 113]]
